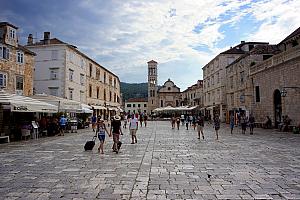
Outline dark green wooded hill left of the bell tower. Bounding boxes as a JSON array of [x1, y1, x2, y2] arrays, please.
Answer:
[[121, 82, 148, 101]]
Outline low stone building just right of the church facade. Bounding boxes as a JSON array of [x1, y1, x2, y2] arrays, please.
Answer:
[[181, 80, 204, 108]]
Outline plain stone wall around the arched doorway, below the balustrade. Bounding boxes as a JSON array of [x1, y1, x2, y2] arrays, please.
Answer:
[[251, 54, 300, 124]]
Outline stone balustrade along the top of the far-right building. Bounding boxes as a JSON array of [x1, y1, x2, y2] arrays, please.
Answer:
[[250, 45, 300, 76]]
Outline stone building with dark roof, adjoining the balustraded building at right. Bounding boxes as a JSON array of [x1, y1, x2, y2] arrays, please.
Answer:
[[225, 44, 279, 122]]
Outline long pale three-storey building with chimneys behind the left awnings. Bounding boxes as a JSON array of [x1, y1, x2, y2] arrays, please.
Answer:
[[26, 32, 120, 117]]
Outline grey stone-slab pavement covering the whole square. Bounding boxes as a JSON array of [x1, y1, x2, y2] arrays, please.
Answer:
[[0, 122, 300, 200]]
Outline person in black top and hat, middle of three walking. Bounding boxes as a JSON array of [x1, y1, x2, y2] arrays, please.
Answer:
[[110, 115, 123, 153]]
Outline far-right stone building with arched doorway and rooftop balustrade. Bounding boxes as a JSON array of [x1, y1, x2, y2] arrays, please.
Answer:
[[250, 28, 300, 127]]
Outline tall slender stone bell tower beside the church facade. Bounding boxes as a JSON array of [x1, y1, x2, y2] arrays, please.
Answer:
[[148, 60, 157, 114]]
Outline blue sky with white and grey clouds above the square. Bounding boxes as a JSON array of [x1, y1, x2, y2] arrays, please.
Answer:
[[0, 0, 300, 90]]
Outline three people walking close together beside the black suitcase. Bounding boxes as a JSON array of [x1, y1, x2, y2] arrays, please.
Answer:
[[92, 114, 141, 154]]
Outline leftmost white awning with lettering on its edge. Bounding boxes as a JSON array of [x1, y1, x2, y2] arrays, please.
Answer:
[[0, 90, 58, 113]]
